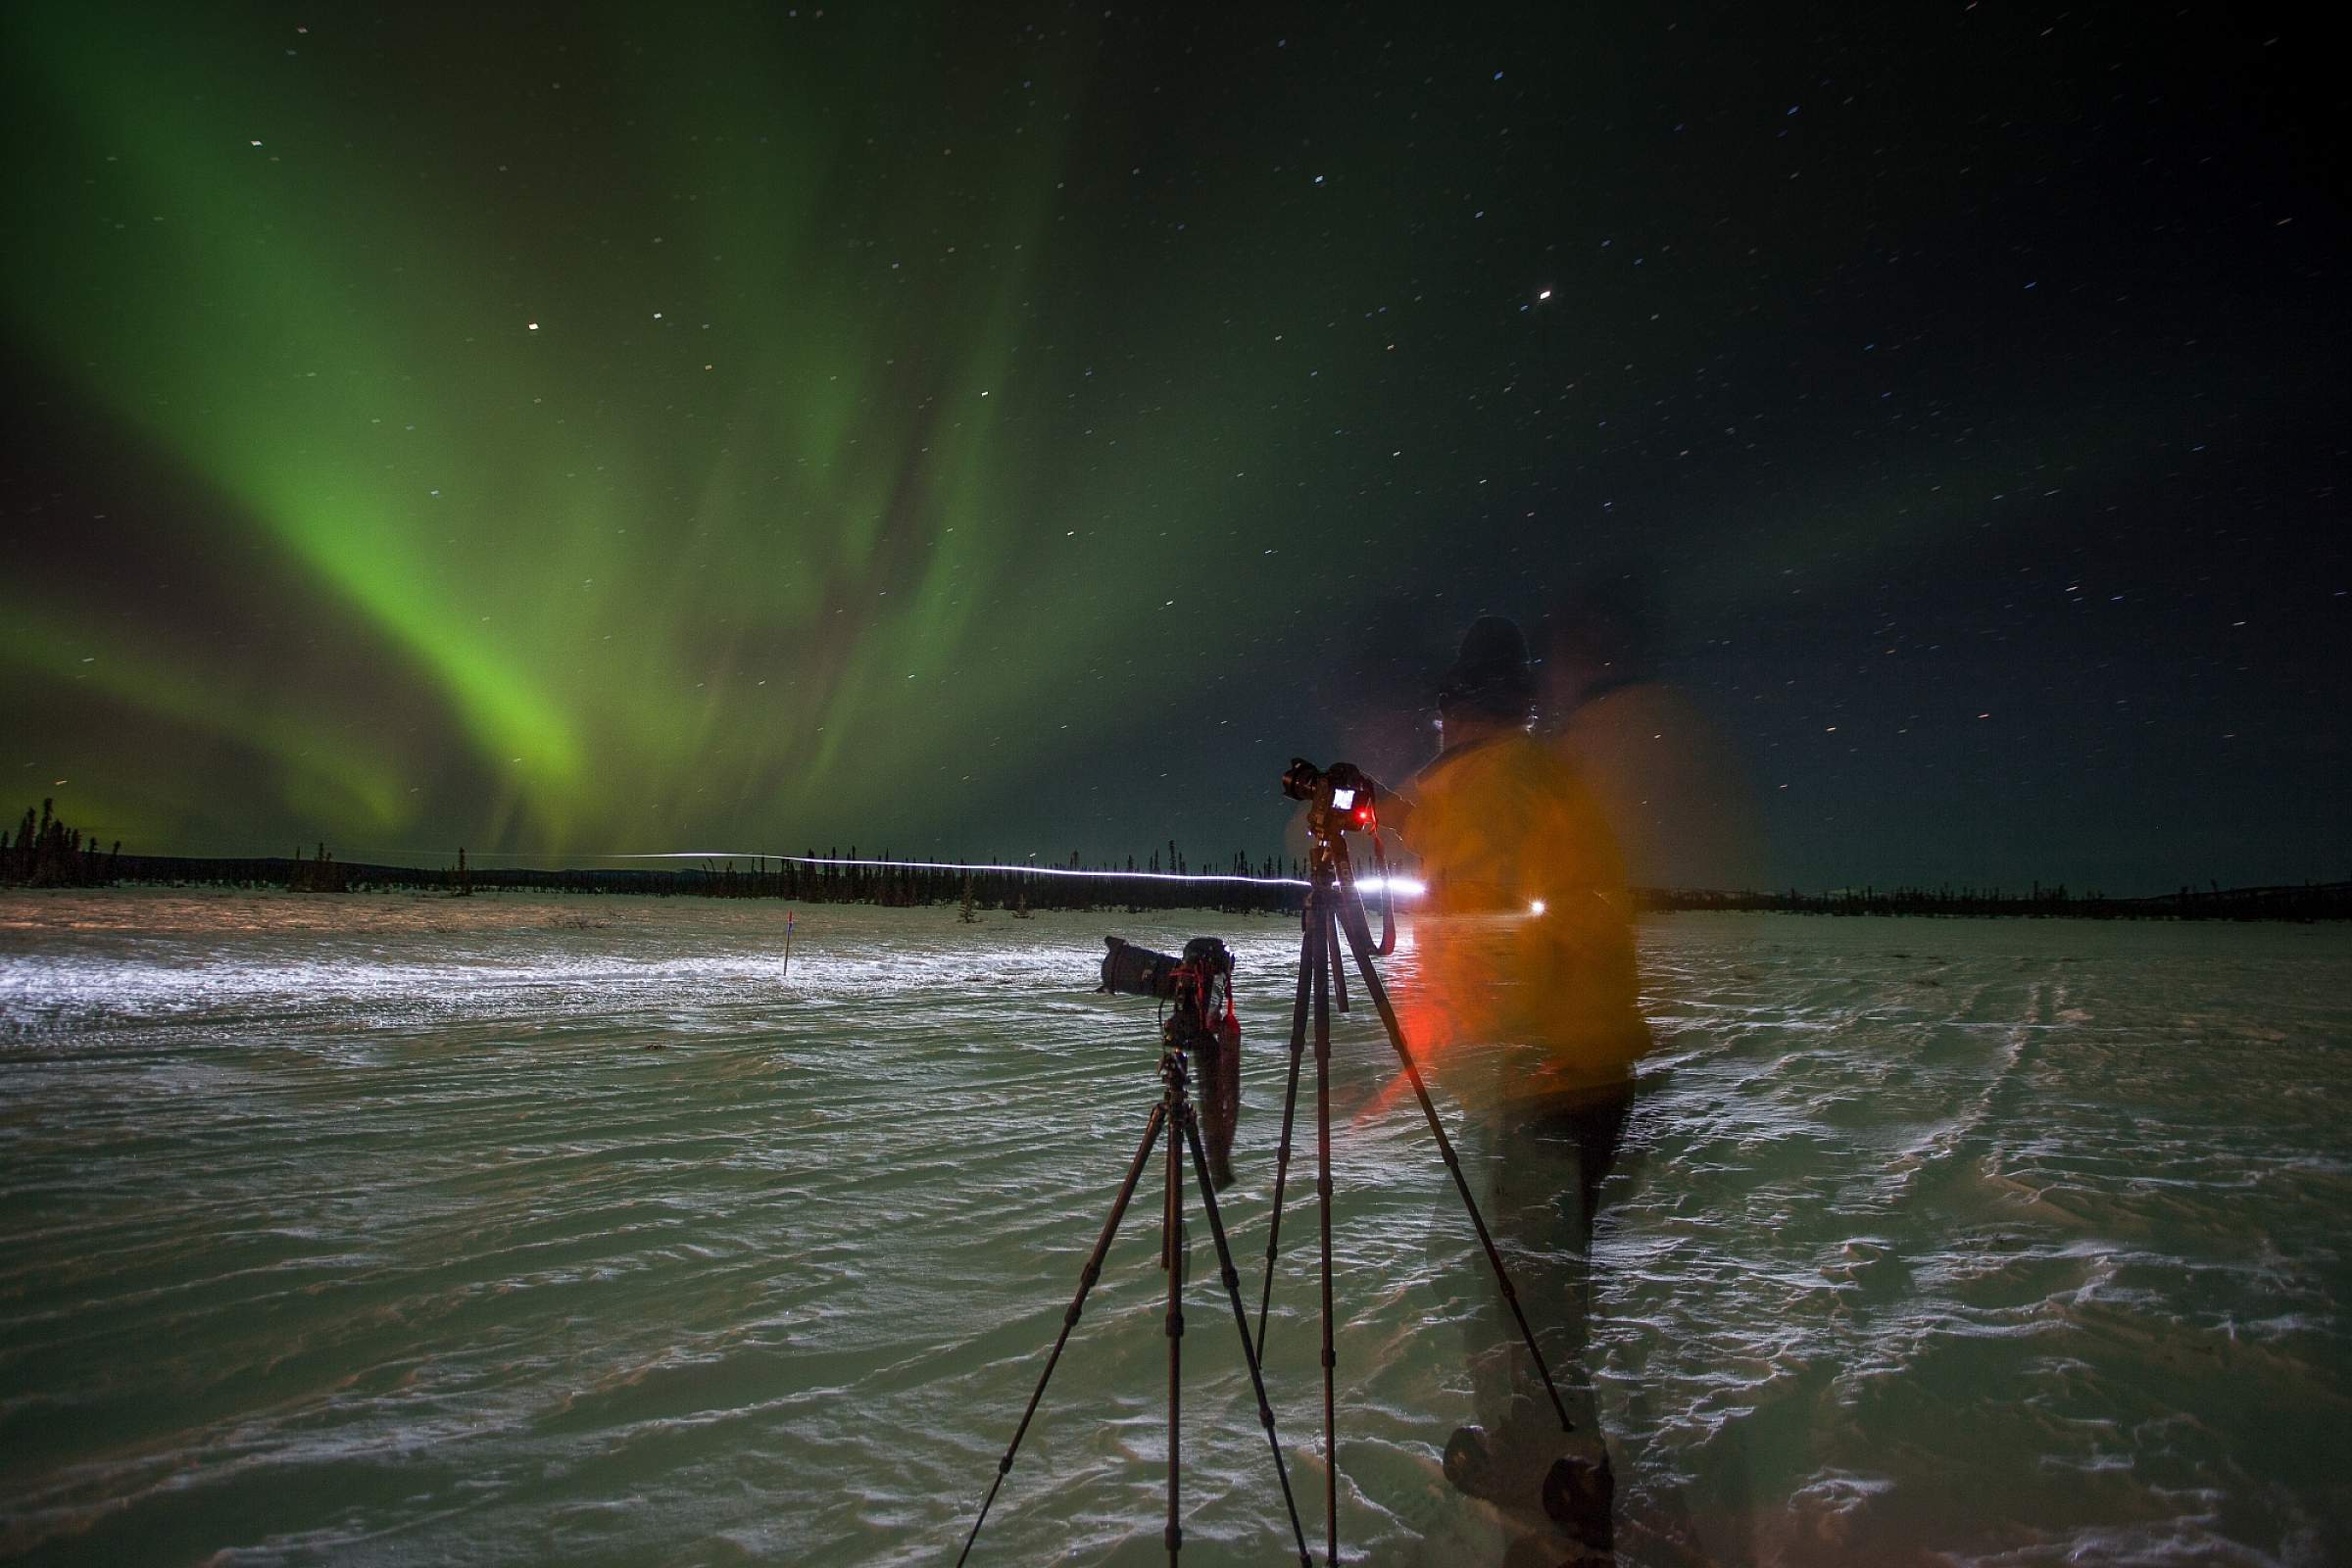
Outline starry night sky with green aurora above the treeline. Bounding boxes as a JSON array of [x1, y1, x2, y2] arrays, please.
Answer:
[[0, 2, 2352, 894]]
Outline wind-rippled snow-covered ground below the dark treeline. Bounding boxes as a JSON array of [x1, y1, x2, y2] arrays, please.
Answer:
[[0, 891, 2352, 1568]]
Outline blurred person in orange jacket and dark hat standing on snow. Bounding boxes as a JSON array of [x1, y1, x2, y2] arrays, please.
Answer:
[[1386, 615, 1651, 1561]]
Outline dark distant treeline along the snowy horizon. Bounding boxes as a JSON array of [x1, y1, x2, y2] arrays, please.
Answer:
[[0, 802, 2352, 921]]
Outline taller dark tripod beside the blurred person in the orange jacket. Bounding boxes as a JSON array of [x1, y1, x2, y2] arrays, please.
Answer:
[[1253, 808, 1576, 1568]]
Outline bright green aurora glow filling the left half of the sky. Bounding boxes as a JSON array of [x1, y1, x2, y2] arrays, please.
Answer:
[[10, 6, 1143, 849]]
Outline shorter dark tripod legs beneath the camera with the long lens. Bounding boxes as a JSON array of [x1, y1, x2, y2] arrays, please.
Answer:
[[955, 1024, 1329, 1568]]
